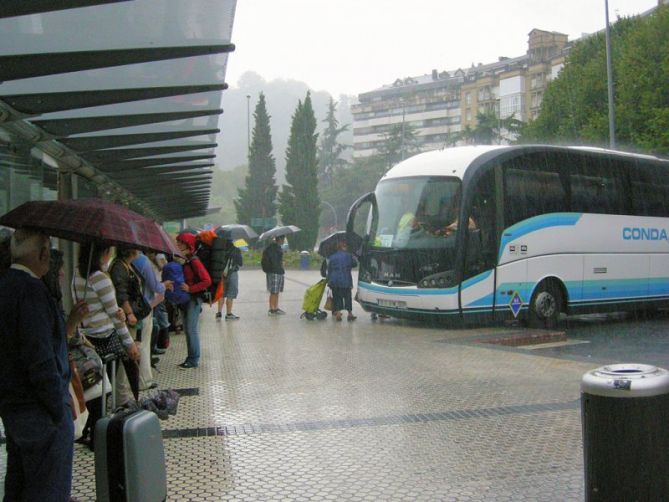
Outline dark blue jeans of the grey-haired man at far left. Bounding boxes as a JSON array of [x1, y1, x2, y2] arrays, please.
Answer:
[[2, 404, 74, 502]]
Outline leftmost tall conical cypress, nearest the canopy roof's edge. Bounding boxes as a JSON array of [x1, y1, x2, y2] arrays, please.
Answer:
[[235, 93, 278, 230]]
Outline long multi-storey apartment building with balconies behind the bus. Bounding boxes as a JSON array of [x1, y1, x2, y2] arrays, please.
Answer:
[[351, 29, 570, 158]]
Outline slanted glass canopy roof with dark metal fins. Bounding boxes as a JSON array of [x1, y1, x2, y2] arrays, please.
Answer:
[[0, 0, 236, 221]]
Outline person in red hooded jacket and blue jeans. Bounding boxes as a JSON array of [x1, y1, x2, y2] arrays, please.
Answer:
[[177, 232, 211, 369]]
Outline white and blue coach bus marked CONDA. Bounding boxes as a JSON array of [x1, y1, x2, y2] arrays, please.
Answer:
[[347, 146, 669, 327]]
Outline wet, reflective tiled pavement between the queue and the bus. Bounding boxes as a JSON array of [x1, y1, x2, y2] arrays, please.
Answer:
[[0, 270, 669, 501]]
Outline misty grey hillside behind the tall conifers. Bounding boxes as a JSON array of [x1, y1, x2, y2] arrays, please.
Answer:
[[216, 72, 355, 180]]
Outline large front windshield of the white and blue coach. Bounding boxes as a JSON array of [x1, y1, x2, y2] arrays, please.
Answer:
[[372, 177, 461, 250]]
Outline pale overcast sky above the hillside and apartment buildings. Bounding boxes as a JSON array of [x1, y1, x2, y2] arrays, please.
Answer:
[[226, 0, 657, 98]]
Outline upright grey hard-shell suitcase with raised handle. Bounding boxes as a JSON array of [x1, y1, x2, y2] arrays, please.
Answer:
[[95, 357, 167, 502]]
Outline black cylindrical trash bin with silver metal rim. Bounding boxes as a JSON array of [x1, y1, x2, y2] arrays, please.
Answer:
[[581, 364, 669, 502]]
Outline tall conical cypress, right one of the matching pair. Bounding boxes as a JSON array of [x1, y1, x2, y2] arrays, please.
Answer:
[[279, 92, 321, 250]]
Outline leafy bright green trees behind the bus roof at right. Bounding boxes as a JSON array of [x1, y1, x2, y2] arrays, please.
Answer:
[[520, 5, 669, 154]]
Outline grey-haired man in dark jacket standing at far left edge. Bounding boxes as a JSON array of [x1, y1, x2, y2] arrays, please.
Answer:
[[0, 229, 74, 502]]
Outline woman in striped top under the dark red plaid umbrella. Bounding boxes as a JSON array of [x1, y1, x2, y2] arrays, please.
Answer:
[[73, 244, 140, 450]]
